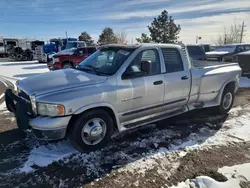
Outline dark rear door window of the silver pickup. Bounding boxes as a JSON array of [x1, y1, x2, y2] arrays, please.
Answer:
[[161, 48, 184, 73]]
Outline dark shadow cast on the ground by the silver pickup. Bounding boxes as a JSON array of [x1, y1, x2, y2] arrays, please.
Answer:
[[0, 109, 231, 187]]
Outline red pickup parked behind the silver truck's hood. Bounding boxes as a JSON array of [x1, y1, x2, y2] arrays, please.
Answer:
[[48, 47, 96, 70]]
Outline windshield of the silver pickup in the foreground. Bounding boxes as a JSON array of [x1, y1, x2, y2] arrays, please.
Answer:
[[77, 47, 135, 75]]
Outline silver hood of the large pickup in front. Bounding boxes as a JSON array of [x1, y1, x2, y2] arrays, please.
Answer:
[[17, 69, 108, 96]]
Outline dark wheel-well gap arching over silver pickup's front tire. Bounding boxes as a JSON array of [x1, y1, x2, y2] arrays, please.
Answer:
[[67, 106, 118, 133]]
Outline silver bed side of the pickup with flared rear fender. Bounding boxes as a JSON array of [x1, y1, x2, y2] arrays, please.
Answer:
[[189, 61, 241, 107]]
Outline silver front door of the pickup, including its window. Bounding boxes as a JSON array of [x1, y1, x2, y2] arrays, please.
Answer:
[[118, 49, 164, 126]]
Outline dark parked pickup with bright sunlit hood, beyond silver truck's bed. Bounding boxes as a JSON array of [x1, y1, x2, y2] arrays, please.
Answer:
[[206, 44, 250, 62]]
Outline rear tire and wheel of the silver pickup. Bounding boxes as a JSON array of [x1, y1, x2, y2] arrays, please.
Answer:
[[218, 87, 235, 114]]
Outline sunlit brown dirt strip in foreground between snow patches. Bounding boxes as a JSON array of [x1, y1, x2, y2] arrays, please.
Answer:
[[84, 142, 250, 188]]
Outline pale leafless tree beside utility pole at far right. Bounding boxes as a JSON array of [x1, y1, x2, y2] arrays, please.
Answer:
[[213, 23, 246, 45]]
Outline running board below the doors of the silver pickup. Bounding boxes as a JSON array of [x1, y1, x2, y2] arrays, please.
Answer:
[[124, 107, 188, 129]]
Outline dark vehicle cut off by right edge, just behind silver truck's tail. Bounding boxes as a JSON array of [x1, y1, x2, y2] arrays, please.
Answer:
[[234, 51, 250, 77]]
